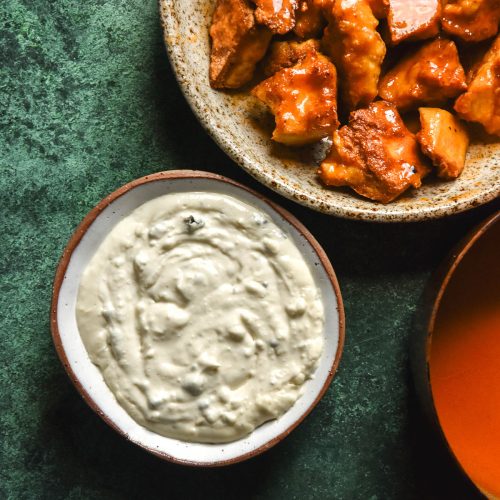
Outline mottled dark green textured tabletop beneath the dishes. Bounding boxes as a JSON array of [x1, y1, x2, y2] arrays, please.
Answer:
[[0, 0, 495, 499]]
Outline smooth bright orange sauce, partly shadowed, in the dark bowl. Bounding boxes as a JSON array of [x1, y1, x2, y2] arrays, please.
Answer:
[[429, 223, 500, 498]]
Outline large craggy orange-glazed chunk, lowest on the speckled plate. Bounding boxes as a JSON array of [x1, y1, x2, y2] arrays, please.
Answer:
[[318, 101, 429, 203]]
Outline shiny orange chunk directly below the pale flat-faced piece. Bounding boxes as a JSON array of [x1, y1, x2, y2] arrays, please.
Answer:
[[379, 39, 467, 111]]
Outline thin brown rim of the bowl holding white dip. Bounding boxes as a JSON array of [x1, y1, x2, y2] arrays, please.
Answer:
[[50, 170, 345, 467]]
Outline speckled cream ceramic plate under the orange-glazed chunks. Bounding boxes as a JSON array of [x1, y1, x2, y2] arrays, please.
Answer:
[[160, 0, 500, 222]]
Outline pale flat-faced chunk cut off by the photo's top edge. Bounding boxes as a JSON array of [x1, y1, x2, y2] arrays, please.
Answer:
[[387, 0, 441, 45]]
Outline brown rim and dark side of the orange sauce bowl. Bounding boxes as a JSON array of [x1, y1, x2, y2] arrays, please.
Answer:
[[412, 210, 500, 495]]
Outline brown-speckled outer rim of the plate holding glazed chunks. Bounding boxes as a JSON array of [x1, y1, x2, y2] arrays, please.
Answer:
[[158, 0, 500, 223]]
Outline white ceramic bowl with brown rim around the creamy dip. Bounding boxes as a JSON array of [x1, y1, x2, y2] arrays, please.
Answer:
[[51, 170, 344, 466]]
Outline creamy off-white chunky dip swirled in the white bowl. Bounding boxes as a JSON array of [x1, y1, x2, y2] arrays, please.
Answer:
[[76, 192, 324, 443]]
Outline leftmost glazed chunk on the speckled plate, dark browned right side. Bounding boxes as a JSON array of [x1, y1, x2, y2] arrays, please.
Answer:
[[210, 0, 272, 89]]
